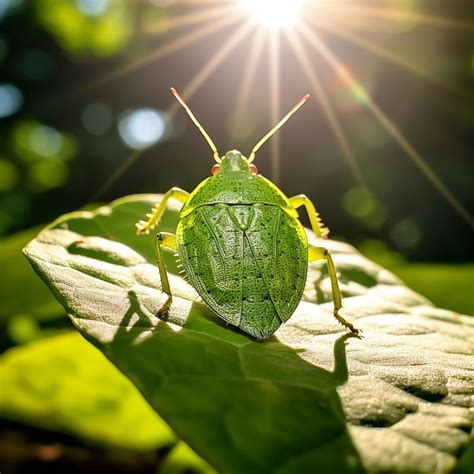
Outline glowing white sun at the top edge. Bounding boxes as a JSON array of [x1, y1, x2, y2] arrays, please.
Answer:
[[240, 0, 305, 29]]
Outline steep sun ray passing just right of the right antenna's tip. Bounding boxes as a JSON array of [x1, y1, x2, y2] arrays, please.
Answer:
[[286, 26, 367, 187]]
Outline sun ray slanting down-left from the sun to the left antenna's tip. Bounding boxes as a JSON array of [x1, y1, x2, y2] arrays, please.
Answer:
[[167, 20, 254, 116]]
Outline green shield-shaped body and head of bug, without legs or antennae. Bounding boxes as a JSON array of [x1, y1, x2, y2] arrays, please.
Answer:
[[176, 151, 308, 338]]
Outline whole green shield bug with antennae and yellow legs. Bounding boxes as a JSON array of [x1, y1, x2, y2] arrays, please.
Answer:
[[136, 88, 360, 339]]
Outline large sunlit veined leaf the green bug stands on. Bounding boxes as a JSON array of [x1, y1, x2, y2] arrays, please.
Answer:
[[25, 195, 474, 473]]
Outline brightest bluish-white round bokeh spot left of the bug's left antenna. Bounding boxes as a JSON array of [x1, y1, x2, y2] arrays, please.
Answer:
[[119, 108, 166, 150]]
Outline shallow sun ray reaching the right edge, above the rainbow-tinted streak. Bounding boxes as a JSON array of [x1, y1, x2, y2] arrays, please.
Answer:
[[308, 18, 472, 97]]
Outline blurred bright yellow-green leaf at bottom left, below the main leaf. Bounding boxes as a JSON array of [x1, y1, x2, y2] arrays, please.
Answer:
[[0, 332, 175, 451]]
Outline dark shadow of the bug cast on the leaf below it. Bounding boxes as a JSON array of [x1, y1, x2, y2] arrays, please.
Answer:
[[107, 291, 363, 472]]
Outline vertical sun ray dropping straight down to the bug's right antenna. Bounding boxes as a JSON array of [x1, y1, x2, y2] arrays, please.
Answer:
[[268, 30, 281, 186]]
